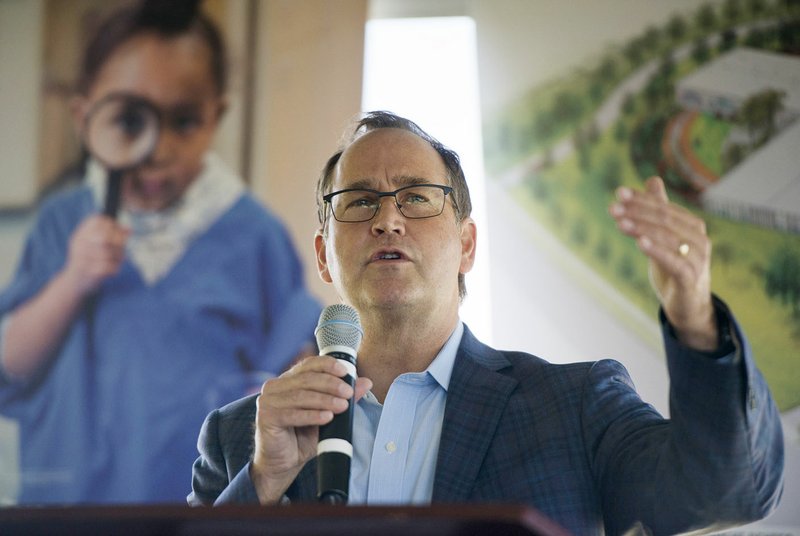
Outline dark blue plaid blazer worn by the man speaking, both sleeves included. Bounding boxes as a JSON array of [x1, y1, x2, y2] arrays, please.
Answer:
[[188, 320, 783, 534]]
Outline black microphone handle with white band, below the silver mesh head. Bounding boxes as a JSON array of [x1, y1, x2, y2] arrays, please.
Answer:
[[317, 352, 356, 504]]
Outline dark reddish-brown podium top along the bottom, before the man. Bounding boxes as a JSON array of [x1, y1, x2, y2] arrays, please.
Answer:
[[0, 504, 568, 536]]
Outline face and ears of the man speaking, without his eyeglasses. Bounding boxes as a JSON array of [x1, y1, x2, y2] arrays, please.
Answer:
[[315, 128, 475, 316]]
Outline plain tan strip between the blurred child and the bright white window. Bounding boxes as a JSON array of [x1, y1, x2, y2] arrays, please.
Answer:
[[250, 0, 367, 303]]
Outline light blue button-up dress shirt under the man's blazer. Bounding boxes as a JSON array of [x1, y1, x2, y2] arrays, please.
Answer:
[[348, 321, 464, 505]]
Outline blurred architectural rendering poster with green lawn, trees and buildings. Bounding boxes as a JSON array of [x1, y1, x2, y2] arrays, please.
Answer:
[[478, 0, 800, 527]]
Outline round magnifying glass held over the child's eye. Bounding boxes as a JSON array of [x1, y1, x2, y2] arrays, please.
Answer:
[[83, 93, 160, 218]]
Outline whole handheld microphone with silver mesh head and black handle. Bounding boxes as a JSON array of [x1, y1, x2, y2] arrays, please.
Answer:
[[314, 304, 364, 504]]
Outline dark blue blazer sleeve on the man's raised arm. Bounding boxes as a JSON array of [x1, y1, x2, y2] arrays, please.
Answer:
[[582, 302, 783, 534]]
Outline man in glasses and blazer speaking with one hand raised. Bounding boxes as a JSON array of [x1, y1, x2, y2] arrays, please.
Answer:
[[188, 112, 783, 534]]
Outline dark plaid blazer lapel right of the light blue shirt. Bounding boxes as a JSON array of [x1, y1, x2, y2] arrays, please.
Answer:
[[432, 328, 517, 502]]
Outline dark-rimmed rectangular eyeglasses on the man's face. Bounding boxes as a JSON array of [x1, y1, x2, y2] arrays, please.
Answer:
[[322, 184, 453, 223]]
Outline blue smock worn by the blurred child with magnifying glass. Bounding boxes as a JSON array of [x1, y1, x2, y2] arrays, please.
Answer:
[[0, 185, 320, 504]]
